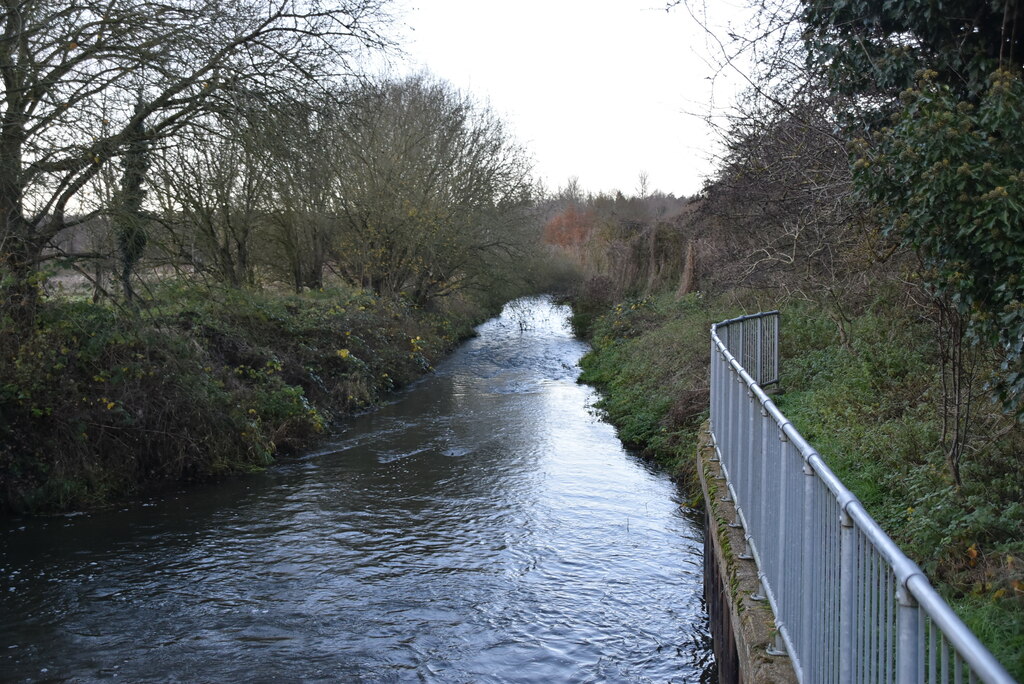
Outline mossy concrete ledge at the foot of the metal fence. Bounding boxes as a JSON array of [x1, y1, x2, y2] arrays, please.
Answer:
[[696, 423, 797, 684]]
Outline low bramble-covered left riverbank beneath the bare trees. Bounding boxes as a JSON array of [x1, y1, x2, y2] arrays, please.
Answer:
[[0, 283, 485, 512]]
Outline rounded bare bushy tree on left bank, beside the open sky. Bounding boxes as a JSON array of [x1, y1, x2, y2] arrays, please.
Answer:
[[335, 76, 531, 302]]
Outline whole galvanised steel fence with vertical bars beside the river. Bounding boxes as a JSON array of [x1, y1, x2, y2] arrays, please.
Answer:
[[711, 311, 1014, 684]]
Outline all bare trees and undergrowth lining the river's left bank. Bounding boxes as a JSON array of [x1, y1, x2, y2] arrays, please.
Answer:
[[0, 0, 577, 512]]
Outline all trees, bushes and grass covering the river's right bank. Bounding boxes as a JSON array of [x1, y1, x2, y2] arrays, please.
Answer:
[[545, 0, 1024, 679]]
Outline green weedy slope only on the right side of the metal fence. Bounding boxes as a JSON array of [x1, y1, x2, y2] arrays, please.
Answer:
[[777, 301, 1024, 680]]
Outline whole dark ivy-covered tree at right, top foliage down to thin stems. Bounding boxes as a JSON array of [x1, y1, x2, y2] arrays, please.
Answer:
[[799, 0, 1024, 471]]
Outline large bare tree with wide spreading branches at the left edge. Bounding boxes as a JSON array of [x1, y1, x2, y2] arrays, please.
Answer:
[[0, 0, 387, 309]]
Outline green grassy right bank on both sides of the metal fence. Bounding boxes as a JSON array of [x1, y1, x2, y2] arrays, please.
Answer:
[[582, 295, 1024, 680]]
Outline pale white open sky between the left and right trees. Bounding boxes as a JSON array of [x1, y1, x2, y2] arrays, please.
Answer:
[[392, 0, 757, 197]]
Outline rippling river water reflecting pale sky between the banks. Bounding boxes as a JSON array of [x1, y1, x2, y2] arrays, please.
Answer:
[[0, 299, 714, 682]]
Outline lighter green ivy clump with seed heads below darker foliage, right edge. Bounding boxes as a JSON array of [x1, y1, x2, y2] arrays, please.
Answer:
[[854, 71, 1024, 419]]
